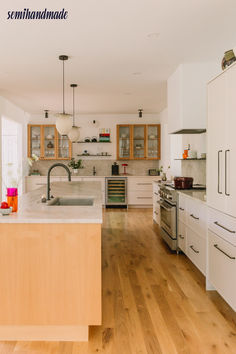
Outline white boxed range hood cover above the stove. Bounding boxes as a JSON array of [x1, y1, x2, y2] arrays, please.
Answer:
[[168, 63, 219, 133]]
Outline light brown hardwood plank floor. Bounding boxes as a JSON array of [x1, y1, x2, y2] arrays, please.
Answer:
[[0, 209, 236, 354]]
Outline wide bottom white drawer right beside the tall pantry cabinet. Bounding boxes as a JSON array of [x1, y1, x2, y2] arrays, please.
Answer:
[[186, 227, 206, 275]]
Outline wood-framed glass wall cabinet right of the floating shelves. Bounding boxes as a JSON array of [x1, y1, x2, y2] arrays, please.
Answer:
[[116, 124, 161, 160]]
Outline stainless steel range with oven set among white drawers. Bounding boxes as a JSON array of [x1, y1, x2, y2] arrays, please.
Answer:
[[158, 185, 177, 251]]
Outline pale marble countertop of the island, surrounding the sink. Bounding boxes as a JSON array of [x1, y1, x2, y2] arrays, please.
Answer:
[[0, 181, 102, 224]]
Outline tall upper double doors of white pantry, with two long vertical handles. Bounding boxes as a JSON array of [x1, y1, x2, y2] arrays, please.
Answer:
[[207, 65, 236, 217]]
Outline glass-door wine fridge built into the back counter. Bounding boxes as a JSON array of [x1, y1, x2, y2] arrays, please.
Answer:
[[106, 177, 127, 207]]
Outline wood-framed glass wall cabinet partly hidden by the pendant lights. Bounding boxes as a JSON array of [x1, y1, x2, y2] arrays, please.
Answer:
[[28, 124, 72, 160]]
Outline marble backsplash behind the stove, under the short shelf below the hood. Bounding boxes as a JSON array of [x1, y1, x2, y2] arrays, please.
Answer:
[[182, 160, 206, 184]]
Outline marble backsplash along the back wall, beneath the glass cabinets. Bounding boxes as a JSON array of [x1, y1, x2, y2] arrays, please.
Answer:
[[31, 159, 159, 176]]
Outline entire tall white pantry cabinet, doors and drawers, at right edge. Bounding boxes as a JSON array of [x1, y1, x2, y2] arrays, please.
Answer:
[[207, 64, 236, 311]]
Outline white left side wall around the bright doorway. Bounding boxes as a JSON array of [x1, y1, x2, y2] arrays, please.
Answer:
[[0, 96, 29, 199]]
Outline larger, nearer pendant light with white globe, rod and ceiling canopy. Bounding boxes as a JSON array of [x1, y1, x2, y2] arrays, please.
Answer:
[[56, 55, 72, 135]]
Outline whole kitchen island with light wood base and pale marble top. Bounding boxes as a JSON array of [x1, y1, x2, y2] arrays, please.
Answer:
[[0, 182, 102, 341]]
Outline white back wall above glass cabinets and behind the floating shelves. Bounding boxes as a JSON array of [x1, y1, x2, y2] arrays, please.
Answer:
[[30, 113, 160, 160]]
